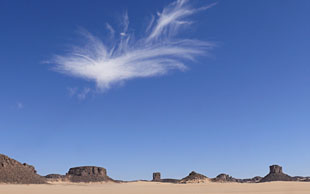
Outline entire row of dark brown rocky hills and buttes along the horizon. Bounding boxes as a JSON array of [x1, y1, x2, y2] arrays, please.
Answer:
[[0, 154, 310, 184]]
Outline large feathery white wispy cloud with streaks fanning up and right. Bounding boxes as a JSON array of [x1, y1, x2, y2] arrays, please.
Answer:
[[52, 0, 214, 91]]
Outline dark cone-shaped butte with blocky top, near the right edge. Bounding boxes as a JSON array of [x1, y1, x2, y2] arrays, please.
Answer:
[[260, 165, 294, 182]]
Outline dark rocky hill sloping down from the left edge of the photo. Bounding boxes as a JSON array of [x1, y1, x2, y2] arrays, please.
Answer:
[[0, 154, 45, 184]]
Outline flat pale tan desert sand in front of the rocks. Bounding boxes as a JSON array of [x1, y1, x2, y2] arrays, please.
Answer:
[[0, 182, 310, 194]]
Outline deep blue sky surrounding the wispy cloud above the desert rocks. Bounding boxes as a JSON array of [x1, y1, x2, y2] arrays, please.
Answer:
[[0, 0, 310, 180]]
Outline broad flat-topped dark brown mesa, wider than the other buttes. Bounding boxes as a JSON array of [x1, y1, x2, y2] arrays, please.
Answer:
[[66, 166, 114, 182]]
